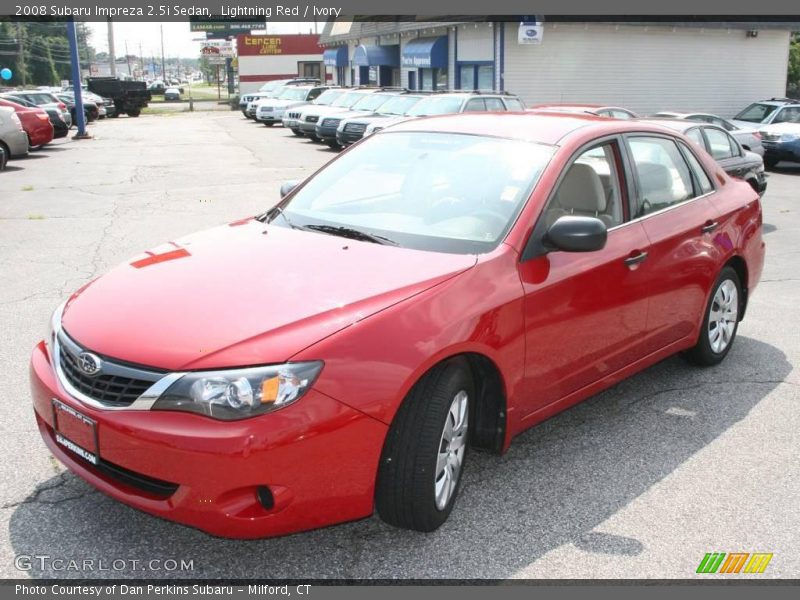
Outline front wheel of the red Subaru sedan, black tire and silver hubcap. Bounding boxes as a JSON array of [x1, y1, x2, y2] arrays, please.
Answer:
[[375, 359, 476, 531]]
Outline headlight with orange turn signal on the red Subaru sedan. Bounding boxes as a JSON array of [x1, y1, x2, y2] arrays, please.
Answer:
[[152, 361, 322, 421]]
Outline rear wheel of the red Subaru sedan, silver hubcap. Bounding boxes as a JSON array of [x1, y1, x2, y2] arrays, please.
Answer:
[[684, 267, 742, 366]]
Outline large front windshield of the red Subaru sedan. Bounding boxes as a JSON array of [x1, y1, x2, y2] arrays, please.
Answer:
[[267, 132, 554, 254]]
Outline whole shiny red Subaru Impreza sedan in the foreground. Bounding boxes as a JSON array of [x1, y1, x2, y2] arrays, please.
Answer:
[[31, 114, 764, 538]]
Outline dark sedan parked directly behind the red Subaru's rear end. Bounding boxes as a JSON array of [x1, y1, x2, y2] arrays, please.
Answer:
[[641, 119, 767, 196]]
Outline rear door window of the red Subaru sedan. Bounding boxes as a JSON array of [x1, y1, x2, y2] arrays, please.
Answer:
[[628, 136, 695, 217]]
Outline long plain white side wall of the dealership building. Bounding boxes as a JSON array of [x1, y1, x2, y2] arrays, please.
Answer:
[[504, 23, 789, 116]]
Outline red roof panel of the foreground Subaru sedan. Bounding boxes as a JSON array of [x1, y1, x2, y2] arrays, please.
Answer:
[[390, 111, 680, 145]]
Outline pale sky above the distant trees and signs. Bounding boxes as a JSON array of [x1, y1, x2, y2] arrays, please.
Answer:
[[87, 21, 321, 58]]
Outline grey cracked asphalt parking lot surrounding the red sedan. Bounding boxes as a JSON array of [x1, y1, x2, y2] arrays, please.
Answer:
[[0, 112, 800, 579]]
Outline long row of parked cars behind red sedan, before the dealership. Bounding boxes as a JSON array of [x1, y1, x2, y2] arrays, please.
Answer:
[[239, 78, 800, 193]]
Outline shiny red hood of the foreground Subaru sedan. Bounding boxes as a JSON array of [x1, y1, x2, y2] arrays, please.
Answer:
[[62, 219, 476, 370]]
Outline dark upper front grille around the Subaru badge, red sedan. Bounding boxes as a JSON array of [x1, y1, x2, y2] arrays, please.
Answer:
[[59, 332, 163, 407]]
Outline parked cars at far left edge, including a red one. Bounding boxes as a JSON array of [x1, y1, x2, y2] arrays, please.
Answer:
[[0, 88, 116, 170]]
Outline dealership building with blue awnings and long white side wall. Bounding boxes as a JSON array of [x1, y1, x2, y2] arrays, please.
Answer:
[[320, 19, 798, 116]]
